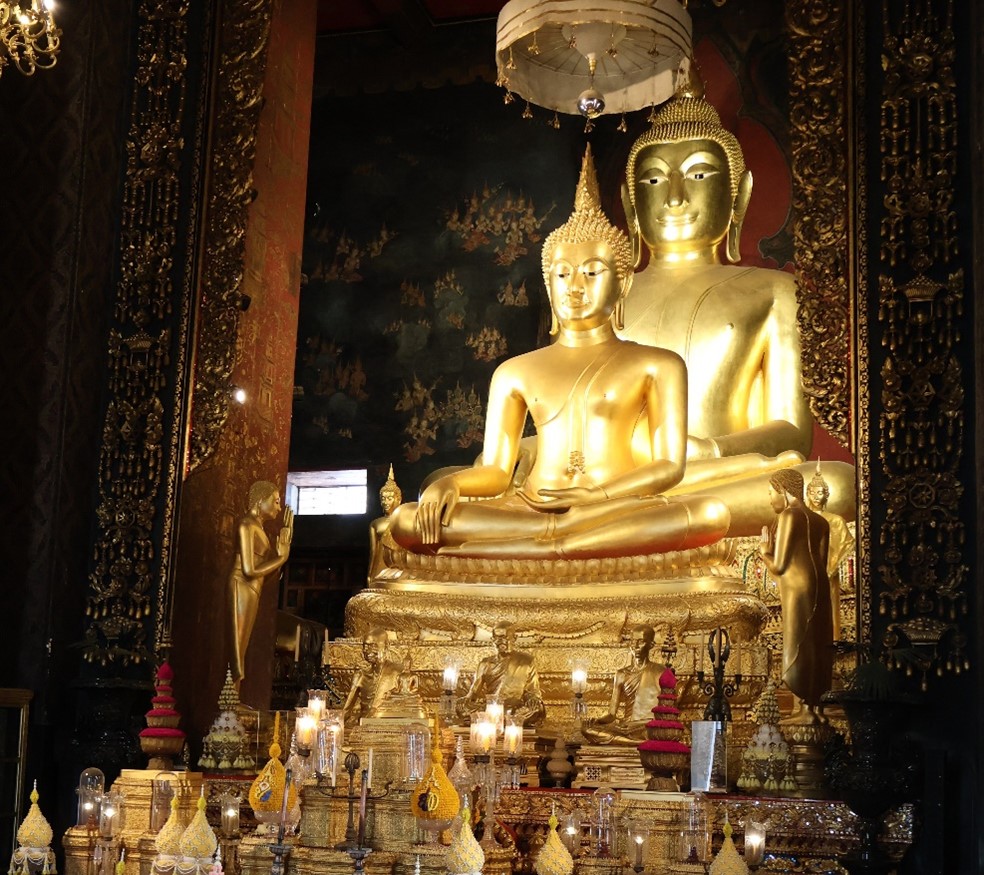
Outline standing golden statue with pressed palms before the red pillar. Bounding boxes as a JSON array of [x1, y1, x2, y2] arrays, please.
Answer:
[[228, 480, 294, 689]]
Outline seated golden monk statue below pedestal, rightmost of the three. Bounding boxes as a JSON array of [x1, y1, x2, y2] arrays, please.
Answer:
[[581, 626, 666, 746]]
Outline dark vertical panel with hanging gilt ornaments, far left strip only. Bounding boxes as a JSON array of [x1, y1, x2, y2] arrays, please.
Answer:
[[84, 0, 189, 665]]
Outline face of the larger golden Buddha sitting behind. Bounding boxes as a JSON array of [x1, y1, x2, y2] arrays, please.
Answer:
[[635, 139, 733, 256]]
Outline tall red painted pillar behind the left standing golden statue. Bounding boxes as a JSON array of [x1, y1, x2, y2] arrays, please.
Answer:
[[172, 0, 316, 755]]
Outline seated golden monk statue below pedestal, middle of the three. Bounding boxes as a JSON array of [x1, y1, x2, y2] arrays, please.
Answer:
[[457, 623, 547, 726]]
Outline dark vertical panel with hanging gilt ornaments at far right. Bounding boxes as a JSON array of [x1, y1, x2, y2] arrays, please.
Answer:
[[877, 0, 969, 688]]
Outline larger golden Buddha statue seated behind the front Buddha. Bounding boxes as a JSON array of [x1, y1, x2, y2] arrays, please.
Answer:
[[619, 68, 855, 536]]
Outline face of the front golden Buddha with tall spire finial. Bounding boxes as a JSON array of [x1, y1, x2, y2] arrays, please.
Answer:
[[549, 240, 621, 330]]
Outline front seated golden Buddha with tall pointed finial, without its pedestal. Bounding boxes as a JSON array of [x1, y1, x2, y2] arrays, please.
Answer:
[[390, 149, 730, 559]]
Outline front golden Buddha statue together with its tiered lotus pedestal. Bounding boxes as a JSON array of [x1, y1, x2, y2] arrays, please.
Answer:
[[346, 150, 769, 641]]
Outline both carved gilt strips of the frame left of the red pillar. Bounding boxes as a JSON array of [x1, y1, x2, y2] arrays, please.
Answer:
[[84, 0, 271, 666]]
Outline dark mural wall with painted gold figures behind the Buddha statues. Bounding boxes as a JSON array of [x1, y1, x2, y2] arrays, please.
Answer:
[[290, 5, 792, 498]]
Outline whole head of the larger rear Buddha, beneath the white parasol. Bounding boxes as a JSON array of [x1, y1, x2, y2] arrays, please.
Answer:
[[623, 65, 752, 263]]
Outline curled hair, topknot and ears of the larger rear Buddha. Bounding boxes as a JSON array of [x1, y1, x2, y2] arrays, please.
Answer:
[[625, 63, 745, 206]]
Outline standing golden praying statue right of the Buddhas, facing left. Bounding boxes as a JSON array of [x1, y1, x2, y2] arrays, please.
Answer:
[[761, 469, 834, 709]]
